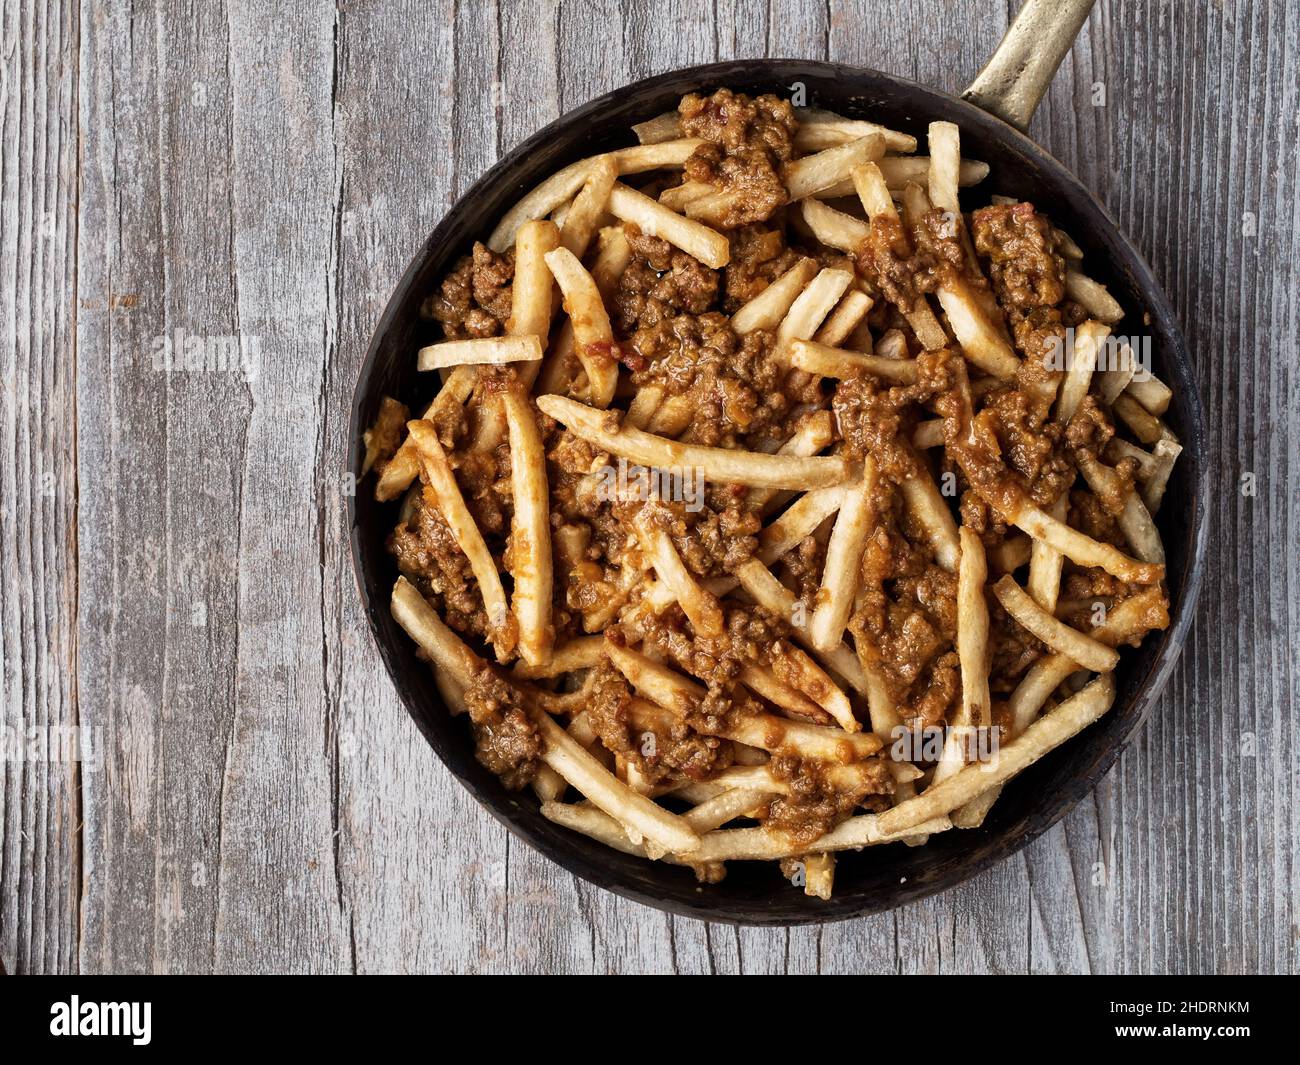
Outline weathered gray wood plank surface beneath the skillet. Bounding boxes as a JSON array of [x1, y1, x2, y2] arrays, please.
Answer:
[[0, 0, 1300, 973]]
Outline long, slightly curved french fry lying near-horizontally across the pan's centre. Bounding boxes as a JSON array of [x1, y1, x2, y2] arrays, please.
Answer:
[[537, 395, 849, 489]]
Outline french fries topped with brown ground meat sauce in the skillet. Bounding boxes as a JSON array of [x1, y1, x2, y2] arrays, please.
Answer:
[[365, 88, 1179, 897]]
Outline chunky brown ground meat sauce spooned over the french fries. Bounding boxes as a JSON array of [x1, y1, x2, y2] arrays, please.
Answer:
[[379, 83, 1169, 880]]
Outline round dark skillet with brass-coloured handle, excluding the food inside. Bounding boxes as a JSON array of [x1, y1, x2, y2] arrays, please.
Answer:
[[348, 0, 1206, 925]]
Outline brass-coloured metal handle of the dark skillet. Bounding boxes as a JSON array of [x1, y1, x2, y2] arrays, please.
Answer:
[[962, 0, 1096, 131]]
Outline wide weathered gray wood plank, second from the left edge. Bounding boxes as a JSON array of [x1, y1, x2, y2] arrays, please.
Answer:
[[78, 5, 348, 971]]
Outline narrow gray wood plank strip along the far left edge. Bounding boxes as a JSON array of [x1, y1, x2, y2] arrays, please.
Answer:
[[0, 3, 81, 971]]
